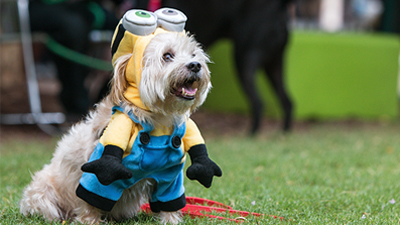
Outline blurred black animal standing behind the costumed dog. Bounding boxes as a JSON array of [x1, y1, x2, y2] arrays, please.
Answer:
[[162, 0, 293, 134]]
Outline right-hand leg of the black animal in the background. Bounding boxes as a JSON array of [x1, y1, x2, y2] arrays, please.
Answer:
[[263, 51, 293, 131]]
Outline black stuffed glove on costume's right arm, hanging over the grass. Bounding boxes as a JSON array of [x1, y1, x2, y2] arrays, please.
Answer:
[[186, 144, 222, 188]]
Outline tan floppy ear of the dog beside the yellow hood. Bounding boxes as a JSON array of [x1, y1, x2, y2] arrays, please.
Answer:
[[110, 54, 132, 105]]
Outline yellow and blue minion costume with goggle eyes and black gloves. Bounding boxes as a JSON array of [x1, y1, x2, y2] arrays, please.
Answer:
[[76, 8, 222, 212]]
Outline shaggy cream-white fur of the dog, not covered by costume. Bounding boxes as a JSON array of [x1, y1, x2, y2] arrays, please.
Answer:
[[20, 30, 211, 224]]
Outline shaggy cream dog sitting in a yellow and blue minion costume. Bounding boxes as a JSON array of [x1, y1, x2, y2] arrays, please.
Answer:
[[20, 8, 222, 224]]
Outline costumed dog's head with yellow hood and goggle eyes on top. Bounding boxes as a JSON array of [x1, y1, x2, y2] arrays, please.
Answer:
[[111, 9, 211, 115]]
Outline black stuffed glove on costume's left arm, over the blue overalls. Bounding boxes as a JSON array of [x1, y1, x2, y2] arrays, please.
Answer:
[[81, 145, 132, 185]]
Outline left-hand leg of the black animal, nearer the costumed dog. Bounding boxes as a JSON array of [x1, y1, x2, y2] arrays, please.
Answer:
[[235, 49, 263, 135]]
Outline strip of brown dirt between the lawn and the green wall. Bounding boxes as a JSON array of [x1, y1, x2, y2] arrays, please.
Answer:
[[0, 110, 400, 143]]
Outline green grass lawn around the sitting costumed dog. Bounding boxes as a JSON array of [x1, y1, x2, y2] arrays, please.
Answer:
[[0, 123, 400, 225]]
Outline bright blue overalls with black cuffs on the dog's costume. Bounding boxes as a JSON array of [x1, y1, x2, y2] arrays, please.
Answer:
[[77, 106, 186, 212]]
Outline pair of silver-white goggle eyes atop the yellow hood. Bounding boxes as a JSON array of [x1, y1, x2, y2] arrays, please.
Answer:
[[122, 8, 187, 36]]
